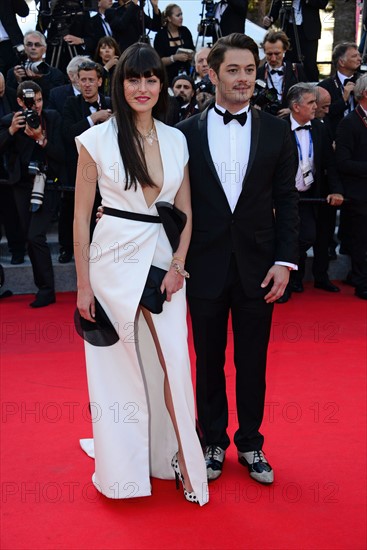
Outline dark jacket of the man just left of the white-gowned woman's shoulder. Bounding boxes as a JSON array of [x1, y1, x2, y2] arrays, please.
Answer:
[[62, 94, 111, 185]]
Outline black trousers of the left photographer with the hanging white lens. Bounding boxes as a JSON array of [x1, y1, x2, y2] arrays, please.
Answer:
[[13, 184, 58, 294]]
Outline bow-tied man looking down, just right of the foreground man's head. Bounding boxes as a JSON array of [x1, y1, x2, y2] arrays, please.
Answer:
[[256, 31, 307, 116]]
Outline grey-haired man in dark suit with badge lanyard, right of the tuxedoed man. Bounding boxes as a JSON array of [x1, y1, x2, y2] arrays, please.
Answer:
[[278, 82, 343, 303]]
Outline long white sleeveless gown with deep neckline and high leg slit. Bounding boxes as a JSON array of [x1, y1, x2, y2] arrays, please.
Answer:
[[76, 118, 208, 505]]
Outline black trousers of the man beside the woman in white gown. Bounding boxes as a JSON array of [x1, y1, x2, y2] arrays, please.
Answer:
[[188, 257, 273, 452]]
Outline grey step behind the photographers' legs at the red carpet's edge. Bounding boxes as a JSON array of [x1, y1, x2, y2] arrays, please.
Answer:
[[0, 229, 350, 294]]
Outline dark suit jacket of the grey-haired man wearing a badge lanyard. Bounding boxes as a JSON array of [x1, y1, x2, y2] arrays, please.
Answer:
[[288, 118, 343, 198]]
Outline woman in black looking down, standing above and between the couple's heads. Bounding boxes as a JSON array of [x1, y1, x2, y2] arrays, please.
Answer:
[[154, 4, 195, 86]]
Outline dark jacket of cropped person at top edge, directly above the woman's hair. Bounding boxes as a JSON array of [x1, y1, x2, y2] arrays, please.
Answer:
[[106, 2, 162, 52]]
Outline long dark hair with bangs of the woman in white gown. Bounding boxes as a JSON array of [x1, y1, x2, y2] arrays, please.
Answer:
[[112, 42, 168, 190]]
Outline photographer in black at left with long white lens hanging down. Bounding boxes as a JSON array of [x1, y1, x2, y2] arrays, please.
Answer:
[[0, 81, 65, 308]]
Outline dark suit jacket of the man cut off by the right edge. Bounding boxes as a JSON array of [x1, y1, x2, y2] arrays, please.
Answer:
[[336, 107, 367, 202]]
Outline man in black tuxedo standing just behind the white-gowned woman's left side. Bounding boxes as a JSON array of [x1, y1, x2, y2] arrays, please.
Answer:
[[59, 61, 111, 263]]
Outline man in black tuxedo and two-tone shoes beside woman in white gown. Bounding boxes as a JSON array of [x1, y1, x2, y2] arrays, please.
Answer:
[[178, 33, 298, 483]]
